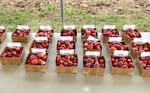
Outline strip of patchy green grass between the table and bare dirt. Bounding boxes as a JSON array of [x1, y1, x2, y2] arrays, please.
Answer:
[[0, 5, 150, 32]]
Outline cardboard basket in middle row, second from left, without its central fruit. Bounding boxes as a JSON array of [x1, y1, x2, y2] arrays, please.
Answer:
[[57, 40, 75, 54]]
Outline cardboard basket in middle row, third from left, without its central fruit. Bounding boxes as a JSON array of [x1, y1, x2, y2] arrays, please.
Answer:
[[83, 41, 102, 55]]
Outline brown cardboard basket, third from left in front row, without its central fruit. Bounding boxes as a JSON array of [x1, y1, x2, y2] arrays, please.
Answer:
[[56, 54, 78, 73]]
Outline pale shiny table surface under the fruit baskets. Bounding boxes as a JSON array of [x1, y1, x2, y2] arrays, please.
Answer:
[[0, 32, 150, 93]]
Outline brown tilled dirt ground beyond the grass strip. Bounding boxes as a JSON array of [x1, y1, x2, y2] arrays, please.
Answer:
[[0, 0, 150, 16]]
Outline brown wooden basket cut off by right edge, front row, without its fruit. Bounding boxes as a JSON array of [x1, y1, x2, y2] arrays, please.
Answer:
[[137, 58, 150, 77]]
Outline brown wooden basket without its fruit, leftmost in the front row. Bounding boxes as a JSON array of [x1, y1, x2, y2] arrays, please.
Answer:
[[0, 47, 25, 65]]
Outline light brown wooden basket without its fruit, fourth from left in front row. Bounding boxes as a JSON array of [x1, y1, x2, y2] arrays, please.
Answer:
[[83, 56, 106, 76]]
